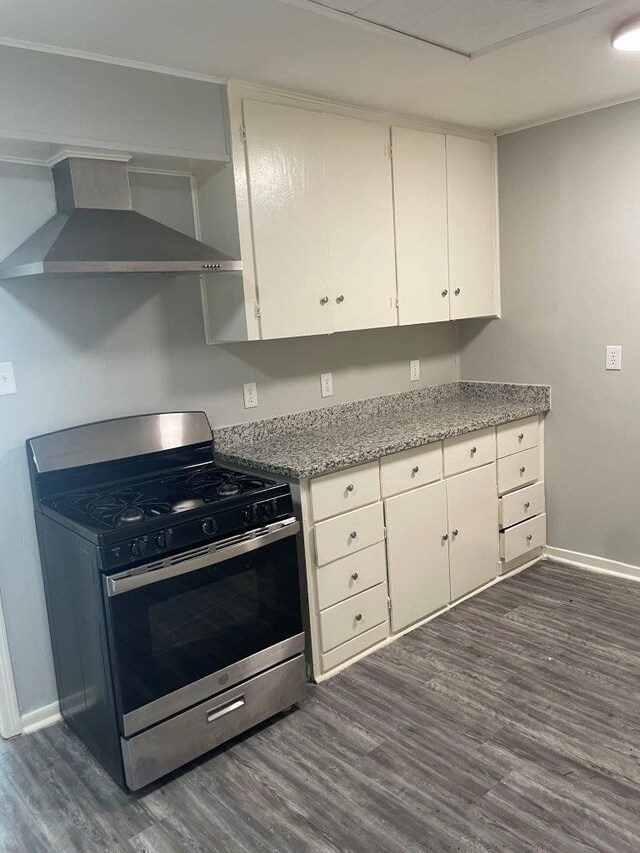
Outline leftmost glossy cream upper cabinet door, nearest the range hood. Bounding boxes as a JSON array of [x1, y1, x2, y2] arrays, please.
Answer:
[[243, 100, 333, 338]]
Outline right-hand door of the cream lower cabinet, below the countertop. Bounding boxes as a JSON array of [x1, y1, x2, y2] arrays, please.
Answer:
[[446, 463, 499, 601]]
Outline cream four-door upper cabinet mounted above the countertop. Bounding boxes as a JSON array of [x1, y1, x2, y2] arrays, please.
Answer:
[[200, 89, 499, 343]]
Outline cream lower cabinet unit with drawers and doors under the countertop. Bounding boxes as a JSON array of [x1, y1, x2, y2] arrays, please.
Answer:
[[301, 417, 546, 678]]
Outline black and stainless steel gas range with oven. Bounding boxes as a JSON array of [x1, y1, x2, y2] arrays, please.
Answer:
[[27, 412, 305, 790]]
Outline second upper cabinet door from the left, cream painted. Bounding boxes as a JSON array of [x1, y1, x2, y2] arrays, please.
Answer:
[[323, 114, 397, 331]]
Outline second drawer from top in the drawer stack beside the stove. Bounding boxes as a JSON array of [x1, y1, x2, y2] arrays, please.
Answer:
[[315, 503, 384, 566]]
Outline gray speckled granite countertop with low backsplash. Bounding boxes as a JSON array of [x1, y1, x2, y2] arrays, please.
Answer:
[[214, 382, 551, 480]]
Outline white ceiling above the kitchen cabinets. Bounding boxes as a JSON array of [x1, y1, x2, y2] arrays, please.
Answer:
[[0, 0, 640, 131]]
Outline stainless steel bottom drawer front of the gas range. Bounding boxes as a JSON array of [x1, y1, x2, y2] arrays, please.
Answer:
[[121, 655, 306, 791]]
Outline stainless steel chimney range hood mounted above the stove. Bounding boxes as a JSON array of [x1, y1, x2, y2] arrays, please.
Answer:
[[0, 157, 242, 278]]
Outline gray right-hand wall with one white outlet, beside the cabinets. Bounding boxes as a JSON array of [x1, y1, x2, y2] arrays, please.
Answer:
[[461, 101, 640, 565]]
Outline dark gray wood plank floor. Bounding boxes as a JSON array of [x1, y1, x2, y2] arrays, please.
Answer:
[[0, 562, 640, 853]]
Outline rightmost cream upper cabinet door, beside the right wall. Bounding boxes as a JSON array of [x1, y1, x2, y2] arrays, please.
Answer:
[[447, 136, 498, 320]]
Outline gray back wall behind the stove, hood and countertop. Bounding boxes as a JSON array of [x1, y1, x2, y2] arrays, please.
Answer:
[[0, 164, 458, 712]]
